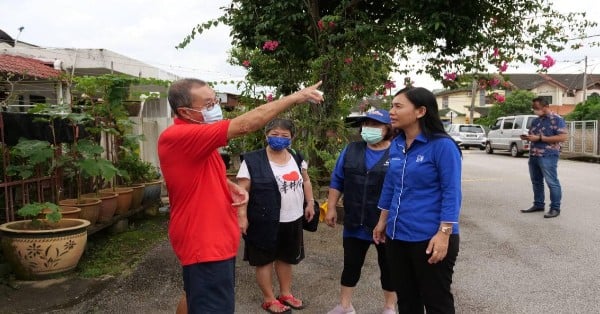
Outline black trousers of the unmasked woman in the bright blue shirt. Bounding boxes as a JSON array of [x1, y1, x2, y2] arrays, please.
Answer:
[[385, 234, 460, 314]]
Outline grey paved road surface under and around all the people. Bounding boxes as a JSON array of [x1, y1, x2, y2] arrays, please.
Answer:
[[0, 150, 600, 314]]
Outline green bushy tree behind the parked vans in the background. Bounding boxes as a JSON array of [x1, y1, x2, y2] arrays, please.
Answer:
[[478, 90, 536, 126]]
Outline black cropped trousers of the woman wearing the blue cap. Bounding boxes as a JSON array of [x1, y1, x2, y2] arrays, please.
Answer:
[[340, 237, 394, 291]]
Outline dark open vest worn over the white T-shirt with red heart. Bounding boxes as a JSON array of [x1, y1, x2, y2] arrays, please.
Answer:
[[242, 148, 302, 249]]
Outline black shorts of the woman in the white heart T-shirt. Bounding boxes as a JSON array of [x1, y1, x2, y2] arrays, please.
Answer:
[[244, 217, 304, 266]]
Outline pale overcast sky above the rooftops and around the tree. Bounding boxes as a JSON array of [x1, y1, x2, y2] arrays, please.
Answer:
[[0, 0, 600, 92]]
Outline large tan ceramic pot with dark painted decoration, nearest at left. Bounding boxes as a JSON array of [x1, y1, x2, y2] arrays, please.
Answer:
[[0, 219, 90, 280]]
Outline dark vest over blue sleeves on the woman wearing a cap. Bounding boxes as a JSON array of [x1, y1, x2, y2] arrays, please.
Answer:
[[343, 141, 389, 229]]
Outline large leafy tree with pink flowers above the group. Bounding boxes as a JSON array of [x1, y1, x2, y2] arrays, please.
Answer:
[[178, 0, 595, 180]]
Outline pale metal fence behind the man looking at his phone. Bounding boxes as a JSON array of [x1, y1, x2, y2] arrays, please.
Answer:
[[562, 120, 600, 155]]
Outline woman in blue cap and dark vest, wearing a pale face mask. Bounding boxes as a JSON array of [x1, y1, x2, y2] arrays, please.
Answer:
[[325, 109, 396, 314]]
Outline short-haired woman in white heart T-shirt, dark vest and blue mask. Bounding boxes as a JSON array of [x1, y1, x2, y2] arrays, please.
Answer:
[[237, 119, 315, 313]]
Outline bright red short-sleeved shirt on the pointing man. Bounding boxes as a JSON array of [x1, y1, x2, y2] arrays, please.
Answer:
[[158, 119, 240, 266]]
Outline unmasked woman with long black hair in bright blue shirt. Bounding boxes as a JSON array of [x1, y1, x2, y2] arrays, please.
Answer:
[[373, 88, 462, 313]]
